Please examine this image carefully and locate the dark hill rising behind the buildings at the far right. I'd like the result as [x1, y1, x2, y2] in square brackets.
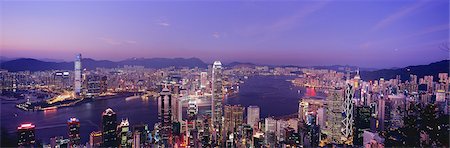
[360, 60, 450, 81]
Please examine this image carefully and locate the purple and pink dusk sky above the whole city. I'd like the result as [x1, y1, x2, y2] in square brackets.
[0, 0, 449, 68]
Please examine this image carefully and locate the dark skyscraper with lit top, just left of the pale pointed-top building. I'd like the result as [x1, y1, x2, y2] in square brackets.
[102, 108, 118, 147]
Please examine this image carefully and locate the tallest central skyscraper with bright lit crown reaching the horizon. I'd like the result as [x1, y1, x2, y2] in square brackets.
[211, 61, 223, 145]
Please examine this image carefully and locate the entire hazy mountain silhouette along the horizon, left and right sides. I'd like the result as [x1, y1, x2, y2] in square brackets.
[0, 58, 450, 81]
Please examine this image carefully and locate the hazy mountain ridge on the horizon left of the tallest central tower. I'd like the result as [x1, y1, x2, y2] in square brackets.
[0, 58, 207, 72]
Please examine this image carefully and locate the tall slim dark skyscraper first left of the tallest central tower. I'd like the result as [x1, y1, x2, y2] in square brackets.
[159, 86, 172, 146]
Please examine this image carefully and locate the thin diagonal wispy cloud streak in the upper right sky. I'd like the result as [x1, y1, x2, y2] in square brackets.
[372, 0, 427, 30]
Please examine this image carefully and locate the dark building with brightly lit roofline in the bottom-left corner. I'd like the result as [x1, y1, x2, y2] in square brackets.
[17, 123, 36, 147]
